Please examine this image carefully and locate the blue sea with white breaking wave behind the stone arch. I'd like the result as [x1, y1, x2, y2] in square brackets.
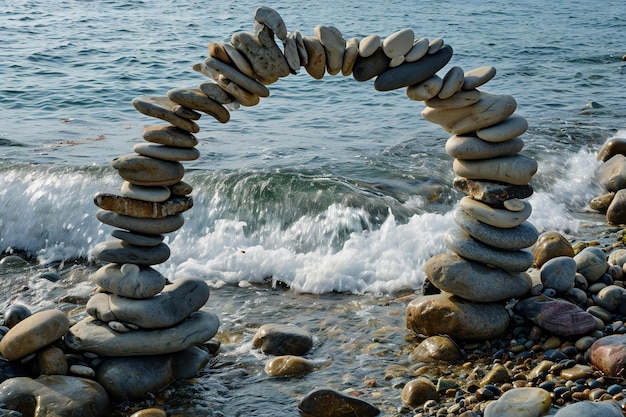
[0, 0, 626, 416]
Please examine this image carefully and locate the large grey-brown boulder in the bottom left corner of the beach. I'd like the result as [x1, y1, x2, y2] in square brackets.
[0, 375, 110, 417]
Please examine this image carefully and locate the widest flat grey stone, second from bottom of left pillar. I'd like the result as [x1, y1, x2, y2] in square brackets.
[64, 311, 220, 356]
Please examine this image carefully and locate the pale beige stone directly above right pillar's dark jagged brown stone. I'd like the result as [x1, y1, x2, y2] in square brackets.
[452, 154, 537, 185]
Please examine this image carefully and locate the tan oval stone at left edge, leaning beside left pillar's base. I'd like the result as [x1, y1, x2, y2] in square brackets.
[0, 309, 70, 361]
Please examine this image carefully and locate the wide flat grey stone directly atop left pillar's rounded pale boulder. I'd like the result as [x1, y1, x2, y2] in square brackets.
[91, 240, 170, 266]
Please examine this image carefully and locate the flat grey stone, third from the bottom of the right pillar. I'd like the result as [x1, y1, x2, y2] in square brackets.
[443, 227, 533, 272]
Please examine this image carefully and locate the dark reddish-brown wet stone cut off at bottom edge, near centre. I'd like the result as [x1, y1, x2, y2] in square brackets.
[298, 389, 380, 417]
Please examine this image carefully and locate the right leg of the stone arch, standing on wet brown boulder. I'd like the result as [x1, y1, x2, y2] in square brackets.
[407, 67, 539, 339]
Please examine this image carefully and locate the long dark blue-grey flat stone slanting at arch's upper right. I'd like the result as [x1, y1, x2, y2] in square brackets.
[374, 45, 452, 91]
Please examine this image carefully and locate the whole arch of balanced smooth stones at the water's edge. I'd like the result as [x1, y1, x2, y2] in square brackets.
[75, 6, 538, 360]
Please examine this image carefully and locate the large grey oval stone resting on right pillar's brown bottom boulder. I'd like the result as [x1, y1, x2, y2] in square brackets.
[424, 254, 532, 303]
